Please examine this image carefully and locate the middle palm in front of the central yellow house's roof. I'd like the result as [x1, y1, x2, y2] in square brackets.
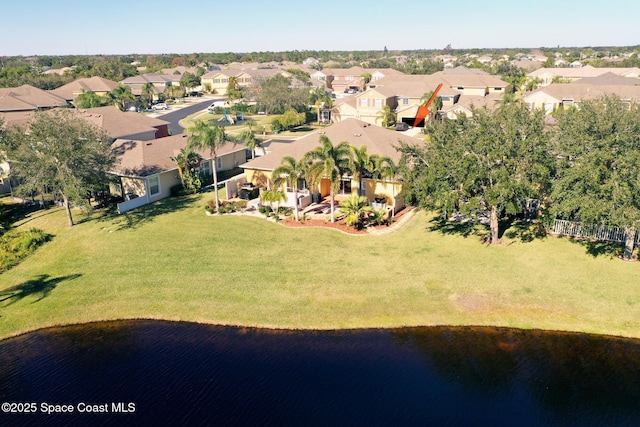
[305, 135, 351, 222]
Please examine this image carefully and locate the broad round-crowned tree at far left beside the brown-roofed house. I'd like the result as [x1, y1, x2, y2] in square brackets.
[4, 110, 116, 226]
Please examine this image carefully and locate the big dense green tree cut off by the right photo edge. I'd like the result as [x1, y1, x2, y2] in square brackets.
[551, 96, 640, 259]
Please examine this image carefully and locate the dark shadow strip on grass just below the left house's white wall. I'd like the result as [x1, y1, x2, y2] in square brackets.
[94, 196, 197, 231]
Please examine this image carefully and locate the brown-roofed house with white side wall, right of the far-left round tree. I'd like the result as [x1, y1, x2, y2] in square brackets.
[111, 133, 247, 213]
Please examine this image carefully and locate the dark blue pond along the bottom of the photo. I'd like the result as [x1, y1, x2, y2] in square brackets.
[0, 321, 640, 426]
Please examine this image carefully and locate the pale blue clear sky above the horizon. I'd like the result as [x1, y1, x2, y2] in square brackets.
[0, 0, 640, 56]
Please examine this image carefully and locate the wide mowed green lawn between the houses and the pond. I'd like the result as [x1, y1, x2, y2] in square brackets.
[0, 194, 640, 338]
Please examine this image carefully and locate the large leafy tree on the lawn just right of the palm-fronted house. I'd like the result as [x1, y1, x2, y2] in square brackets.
[401, 102, 552, 244]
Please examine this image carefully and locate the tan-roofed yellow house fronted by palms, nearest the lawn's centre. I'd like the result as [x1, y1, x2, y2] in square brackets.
[240, 119, 420, 211]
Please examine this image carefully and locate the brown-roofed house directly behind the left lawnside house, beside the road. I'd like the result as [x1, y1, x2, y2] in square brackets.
[76, 106, 169, 141]
